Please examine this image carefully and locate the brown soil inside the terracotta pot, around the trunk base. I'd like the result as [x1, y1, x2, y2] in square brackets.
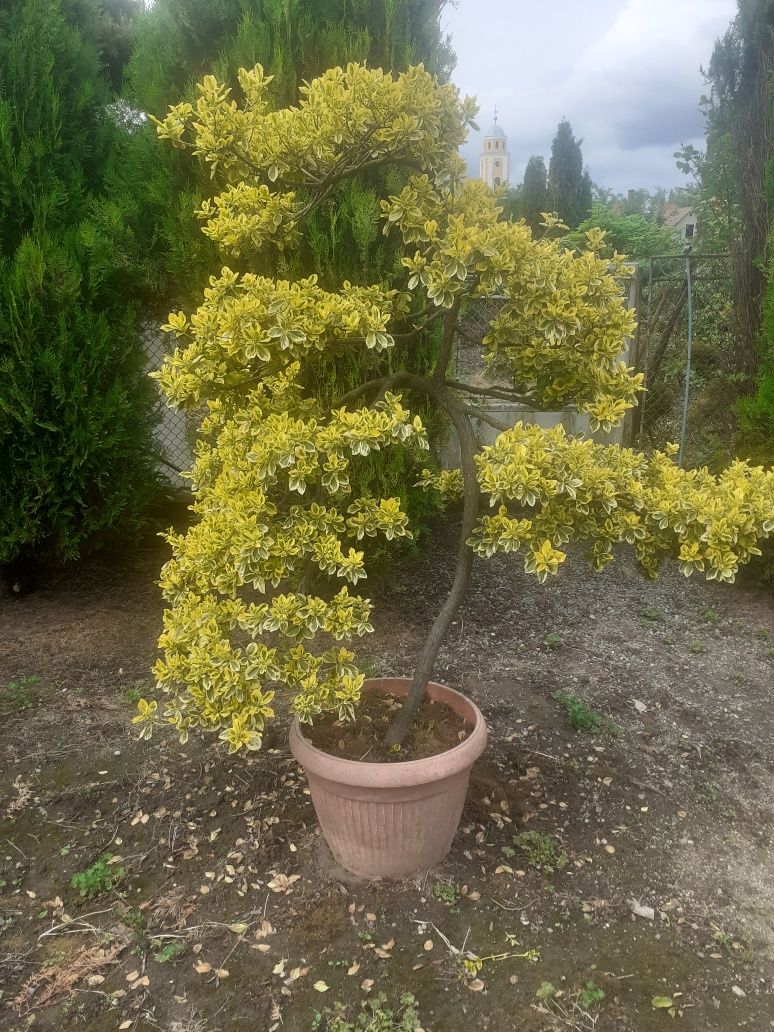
[302, 691, 471, 764]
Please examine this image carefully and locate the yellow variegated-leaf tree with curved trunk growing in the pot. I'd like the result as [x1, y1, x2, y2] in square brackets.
[135, 64, 774, 750]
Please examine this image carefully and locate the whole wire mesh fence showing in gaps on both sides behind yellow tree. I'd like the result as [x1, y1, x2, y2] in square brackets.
[142, 253, 733, 487]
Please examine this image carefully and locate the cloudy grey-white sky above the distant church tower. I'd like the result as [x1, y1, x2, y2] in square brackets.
[444, 0, 736, 191]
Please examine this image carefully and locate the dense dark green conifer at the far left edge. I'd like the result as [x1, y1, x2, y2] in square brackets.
[0, 0, 154, 582]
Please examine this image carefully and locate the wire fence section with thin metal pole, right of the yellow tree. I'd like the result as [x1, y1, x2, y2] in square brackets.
[634, 252, 734, 466]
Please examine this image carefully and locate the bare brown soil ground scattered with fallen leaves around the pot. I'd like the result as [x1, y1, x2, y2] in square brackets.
[0, 525, 774, 1032]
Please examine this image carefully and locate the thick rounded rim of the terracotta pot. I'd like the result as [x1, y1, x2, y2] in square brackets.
[290, 677, 488, 788]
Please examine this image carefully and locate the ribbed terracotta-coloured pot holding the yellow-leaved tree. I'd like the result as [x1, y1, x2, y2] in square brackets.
[290, 677, 487, 878]
